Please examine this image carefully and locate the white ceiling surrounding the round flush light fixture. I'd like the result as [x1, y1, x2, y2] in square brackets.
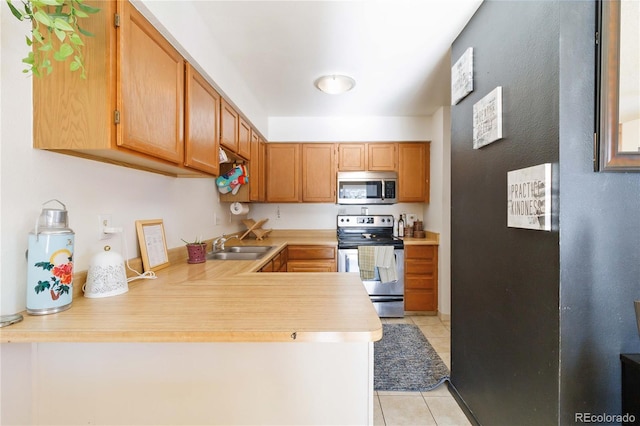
[193, 0, 482, 117]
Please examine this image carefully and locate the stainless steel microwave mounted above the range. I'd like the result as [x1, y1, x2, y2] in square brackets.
[336, 172, 398, 204]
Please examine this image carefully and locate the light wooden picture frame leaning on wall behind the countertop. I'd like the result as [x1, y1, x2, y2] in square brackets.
[136, 219, 169, 272]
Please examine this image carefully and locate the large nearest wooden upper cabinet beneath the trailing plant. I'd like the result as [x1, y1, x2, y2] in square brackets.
[32, 1, 212, 176]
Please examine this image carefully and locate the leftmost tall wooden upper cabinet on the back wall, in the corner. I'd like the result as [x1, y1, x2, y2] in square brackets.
[264, 143, 301, 203]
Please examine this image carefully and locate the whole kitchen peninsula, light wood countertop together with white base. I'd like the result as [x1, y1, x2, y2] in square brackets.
[0, 238, 382, 424]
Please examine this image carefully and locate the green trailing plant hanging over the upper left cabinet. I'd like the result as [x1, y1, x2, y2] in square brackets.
[6, 0, 100, 79]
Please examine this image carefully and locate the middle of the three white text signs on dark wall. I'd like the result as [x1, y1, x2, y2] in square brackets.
[473, 86, 502, 149]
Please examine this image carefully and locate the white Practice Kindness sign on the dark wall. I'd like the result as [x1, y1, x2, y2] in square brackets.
[507, 163, 551, 231]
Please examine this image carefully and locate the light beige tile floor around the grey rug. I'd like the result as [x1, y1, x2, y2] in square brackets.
[373, 316, 471, 426]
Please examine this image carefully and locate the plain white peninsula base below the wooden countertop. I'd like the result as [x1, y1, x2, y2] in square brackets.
[0, 342, 373, 425]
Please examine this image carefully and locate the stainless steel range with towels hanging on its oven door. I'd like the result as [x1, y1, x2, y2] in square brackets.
[337, 215, 404, 317]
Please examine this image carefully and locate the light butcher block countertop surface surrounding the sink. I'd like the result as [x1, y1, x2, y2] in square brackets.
[0, 231, 382, 343]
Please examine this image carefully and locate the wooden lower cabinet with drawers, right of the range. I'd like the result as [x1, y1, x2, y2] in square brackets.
[404, 245, 438, 311]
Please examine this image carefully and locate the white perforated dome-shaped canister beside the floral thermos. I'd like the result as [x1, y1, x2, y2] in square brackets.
[82, 246, 129, 298]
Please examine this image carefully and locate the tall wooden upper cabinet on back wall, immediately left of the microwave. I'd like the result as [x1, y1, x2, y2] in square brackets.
[301, 143, 336, 203]
